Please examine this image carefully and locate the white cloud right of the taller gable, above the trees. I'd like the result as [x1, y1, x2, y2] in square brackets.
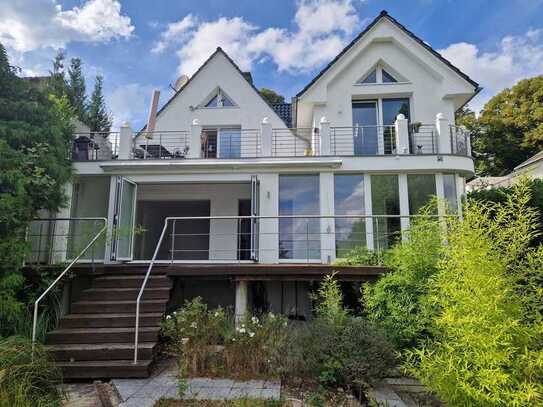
[439, 29, 543, 112]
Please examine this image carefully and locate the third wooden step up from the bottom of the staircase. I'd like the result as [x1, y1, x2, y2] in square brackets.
[46, 326, 160, 345]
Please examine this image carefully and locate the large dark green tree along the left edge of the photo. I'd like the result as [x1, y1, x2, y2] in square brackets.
[0, 44, 72, 336]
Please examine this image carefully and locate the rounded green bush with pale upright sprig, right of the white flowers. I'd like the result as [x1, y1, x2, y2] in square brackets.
[285, 276, 394, 387]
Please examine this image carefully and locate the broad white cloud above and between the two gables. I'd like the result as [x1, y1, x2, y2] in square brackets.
[153, 0, 360, 74]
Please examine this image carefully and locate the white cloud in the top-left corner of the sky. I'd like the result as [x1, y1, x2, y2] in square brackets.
[0, 0, 134, 53]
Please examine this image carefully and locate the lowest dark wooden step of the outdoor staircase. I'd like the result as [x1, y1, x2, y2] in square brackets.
[57, 359, 152, 380]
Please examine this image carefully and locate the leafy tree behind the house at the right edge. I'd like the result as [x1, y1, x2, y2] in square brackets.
[458, 76, 543, 176]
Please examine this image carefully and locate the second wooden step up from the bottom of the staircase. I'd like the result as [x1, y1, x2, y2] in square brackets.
[45, 342, 156, 362]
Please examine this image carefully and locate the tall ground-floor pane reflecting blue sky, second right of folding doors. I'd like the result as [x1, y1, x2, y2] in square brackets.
[334, 174, 366, 257]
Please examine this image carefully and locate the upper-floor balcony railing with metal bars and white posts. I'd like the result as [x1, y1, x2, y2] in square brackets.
[71, 115, 471, 161]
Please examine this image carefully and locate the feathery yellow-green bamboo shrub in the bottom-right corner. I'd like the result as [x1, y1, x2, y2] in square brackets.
[406, 184, 543, 406]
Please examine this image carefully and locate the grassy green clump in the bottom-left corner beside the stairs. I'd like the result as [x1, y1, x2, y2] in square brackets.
[0, 336, 63, 407]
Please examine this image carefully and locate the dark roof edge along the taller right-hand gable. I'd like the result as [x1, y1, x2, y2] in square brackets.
[296, 10, 482, 97]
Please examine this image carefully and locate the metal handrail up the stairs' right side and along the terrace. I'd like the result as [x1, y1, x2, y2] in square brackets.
[133, 214, 452, 364]
